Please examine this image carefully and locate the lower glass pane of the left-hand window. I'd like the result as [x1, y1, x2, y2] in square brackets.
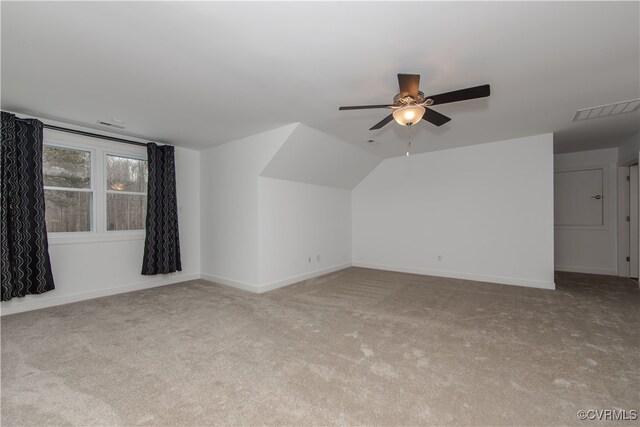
[44, 190, 93, 233]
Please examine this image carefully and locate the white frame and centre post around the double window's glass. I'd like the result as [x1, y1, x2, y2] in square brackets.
[44, 129, 148, 245]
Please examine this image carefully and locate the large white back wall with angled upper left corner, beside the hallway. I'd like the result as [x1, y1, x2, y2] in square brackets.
[352, 134, 554, 288]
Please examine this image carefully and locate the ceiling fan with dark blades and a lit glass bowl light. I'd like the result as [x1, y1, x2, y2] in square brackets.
[339, 74, 491, 130]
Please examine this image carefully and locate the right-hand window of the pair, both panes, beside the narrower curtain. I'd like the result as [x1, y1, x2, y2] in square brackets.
[106, 155, 148, 231]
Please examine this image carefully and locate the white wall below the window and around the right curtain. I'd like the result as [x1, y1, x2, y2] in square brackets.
[2, 147, 200, 315]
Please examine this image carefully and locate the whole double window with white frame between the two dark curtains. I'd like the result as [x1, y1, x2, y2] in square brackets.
[43, 129, 148, 237]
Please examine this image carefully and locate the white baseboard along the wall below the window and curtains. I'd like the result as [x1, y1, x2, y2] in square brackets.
[0, 273, 200, 316]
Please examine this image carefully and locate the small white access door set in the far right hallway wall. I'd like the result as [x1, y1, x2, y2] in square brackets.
[553, 169, 604, 226]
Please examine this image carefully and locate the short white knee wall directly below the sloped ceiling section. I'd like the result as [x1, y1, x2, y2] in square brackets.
[259, 178, 351, 291]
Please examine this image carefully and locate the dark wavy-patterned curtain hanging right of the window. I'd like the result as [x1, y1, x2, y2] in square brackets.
[142, 143, 182, 275]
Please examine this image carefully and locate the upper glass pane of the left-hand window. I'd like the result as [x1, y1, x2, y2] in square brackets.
[42, 145, 91, 188]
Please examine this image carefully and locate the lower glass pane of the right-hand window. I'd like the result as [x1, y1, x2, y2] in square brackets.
[107, 193, 147, 231]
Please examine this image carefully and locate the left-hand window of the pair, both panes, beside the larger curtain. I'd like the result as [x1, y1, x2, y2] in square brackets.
[42, 145, 93, 232]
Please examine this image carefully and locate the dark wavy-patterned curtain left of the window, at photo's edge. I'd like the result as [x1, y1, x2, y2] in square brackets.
[0, 111, 54, 301]
